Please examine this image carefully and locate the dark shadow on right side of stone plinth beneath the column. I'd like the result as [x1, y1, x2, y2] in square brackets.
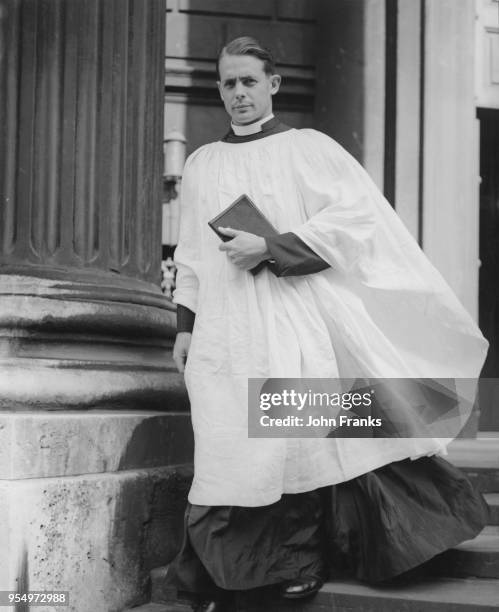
[108, 414, 194, 605]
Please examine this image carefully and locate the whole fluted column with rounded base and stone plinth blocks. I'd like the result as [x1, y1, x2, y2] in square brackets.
[0, 0, 192, 612]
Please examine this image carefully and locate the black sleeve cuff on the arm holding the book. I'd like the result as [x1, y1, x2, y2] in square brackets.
[265, 232, 331, 276]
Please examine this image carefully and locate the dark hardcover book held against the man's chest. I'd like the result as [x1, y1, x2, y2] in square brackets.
[208, 194, 279, 274]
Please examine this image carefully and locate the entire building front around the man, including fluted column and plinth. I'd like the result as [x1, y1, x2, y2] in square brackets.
[0, 0, 499, 612]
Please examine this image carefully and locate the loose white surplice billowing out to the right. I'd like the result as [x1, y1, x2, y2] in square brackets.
[174, 129, 487, 506]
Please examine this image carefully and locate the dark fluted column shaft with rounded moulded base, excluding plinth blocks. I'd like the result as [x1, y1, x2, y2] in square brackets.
[0, 0, 180, 408]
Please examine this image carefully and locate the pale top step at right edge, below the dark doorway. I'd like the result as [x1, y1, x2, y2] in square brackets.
[445, 434, 499, 493]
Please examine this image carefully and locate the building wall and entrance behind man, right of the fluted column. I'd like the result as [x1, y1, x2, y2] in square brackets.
[165, 0, 499, 430]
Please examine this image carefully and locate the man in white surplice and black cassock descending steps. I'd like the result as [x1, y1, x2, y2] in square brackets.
[170, 37, 487, 611]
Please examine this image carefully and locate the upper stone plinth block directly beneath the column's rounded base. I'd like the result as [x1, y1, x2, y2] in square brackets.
[0, 410, 194, 479]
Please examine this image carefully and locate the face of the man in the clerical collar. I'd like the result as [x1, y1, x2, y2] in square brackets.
[218, 55, 281, 125]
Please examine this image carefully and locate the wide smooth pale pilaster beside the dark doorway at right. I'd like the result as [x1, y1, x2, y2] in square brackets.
[422, 0, 479, 318]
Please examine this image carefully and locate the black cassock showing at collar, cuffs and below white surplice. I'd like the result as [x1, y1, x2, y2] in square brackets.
[168, 119, 488, 594]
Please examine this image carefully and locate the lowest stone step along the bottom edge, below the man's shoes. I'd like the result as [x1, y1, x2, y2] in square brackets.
[146, 578, 499, 612]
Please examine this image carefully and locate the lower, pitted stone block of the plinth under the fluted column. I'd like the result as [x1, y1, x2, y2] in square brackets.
[0, 466, 192, 612]
